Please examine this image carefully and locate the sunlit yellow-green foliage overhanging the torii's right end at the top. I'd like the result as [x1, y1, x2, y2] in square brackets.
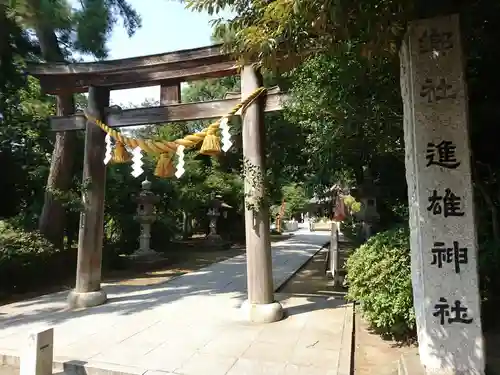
[185, 0, 415, 70]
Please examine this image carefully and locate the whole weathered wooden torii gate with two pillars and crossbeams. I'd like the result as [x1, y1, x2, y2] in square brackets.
[28, 45, 284, 322]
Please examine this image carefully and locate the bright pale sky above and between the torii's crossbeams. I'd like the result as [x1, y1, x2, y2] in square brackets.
[72, 0, 229, 106]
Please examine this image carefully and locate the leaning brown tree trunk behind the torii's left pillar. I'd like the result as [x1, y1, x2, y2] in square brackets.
[35, 22, 77, 248]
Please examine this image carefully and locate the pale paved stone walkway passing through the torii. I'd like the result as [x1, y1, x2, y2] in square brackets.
[0, 230, 352, 375]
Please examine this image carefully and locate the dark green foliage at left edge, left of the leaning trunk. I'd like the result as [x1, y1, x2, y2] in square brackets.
[0, 11, 54, 218]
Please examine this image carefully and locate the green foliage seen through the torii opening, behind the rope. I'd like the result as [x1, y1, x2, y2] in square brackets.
[101, 77, 250, 247]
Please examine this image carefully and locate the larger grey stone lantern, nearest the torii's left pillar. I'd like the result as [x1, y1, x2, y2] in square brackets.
[132, 179, 160, 257]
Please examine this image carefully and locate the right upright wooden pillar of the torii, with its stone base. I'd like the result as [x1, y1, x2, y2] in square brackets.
[241, 66, 283, 323]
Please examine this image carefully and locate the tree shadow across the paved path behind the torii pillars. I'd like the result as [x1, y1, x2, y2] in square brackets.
[0, 235, 332, 337]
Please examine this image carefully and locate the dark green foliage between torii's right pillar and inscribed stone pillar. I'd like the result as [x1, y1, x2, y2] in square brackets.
[285, 45, 404, 195]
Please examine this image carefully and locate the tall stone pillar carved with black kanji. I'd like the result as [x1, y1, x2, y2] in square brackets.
[400, 15, 485, 375]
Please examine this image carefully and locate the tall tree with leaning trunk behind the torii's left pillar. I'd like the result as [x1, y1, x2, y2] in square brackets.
[2, 0, 141, 247]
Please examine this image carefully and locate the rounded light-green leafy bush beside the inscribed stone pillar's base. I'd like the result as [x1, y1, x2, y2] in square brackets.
[347, 228, 415, 338]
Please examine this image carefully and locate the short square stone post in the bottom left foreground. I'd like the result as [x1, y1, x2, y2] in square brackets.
[20, 328, 54, 375]
